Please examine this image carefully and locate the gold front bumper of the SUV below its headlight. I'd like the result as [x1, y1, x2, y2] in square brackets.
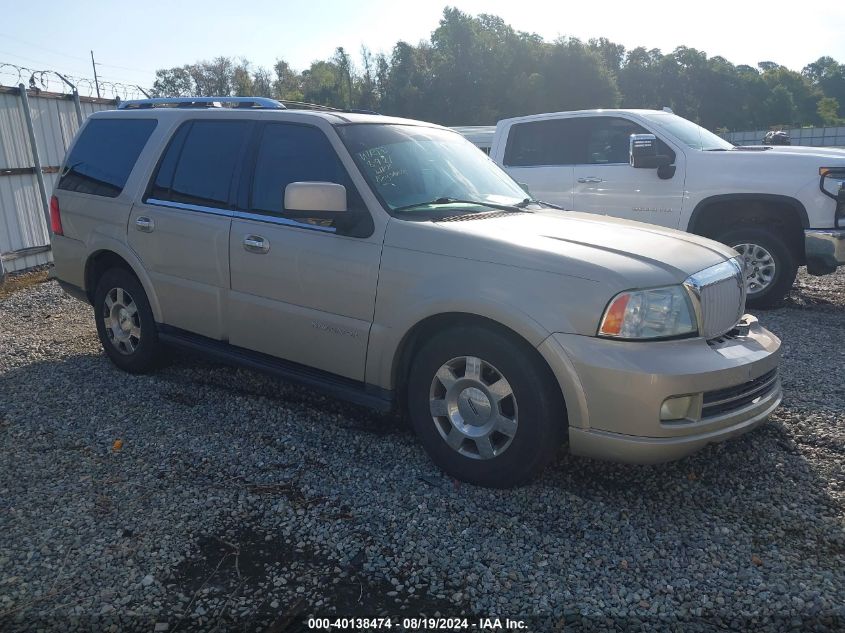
[540, 316, 782, 463]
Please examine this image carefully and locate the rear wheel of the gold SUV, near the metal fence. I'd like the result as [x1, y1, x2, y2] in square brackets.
[94, 268, 161, 374]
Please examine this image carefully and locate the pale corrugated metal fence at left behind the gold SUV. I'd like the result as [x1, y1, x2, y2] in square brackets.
[0, 86, 115, 272]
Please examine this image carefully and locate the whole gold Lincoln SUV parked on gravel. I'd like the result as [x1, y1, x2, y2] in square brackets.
[51, 98, 781, 486]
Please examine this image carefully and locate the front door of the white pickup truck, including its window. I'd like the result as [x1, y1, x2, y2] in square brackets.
[572, 116, 685, 228]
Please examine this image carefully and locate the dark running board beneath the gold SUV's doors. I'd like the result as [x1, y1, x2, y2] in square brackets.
[158, 325, 394, 412]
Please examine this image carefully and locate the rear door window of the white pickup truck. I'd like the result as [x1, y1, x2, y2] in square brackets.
[504, 118, 584, 167]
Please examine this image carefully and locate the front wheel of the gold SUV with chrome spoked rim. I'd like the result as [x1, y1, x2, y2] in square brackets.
[408, 327, 567, 488]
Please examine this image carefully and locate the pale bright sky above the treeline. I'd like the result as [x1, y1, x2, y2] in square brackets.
[0, 0, 845, 93]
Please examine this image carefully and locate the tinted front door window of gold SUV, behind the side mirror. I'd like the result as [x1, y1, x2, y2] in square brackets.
[250, 123, 364, 214]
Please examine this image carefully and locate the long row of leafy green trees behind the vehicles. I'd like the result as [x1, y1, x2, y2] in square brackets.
[148, 7, 845, 130]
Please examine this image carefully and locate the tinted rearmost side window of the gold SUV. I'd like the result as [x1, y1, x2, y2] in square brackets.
[59, 119, 156, 198]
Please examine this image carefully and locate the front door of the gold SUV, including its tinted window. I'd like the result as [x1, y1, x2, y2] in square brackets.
[229, 123, 382, 381]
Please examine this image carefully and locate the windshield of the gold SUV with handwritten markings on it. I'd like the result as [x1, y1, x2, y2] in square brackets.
[338, 124, 526, 213]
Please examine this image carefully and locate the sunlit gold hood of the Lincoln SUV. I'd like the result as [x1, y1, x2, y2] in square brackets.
[386, 210, 736, 292]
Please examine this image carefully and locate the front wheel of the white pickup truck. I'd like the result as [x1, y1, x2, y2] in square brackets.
[717, 227, 798, 308]
